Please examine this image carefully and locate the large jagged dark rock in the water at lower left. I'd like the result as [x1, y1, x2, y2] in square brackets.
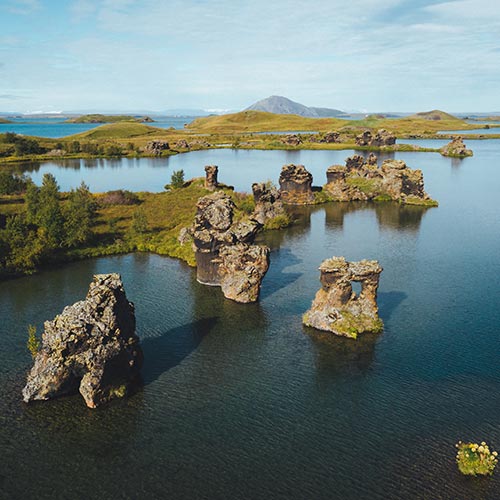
[23, 274, 143, 408]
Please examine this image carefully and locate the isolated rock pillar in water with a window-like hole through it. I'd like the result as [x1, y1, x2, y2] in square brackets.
[303, 257, 382, 338]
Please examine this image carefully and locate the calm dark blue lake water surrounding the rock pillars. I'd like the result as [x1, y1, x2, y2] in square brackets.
[0, 140, 500, 500]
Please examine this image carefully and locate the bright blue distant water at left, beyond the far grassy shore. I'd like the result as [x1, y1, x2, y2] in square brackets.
[0, 116, 194, 139]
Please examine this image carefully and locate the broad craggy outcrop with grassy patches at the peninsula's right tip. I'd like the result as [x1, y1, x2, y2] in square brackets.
[324, 154, 437, 206]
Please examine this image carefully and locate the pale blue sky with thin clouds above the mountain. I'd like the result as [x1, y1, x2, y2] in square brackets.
[0, 0, 500, 112]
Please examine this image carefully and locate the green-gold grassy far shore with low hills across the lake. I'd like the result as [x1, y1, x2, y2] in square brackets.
[0, 111, 492, 165]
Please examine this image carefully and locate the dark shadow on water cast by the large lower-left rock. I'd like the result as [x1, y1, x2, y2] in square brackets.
[141, 317, 218, 385]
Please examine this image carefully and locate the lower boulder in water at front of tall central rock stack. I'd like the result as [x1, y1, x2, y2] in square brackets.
[219, 243, 269, 303]
